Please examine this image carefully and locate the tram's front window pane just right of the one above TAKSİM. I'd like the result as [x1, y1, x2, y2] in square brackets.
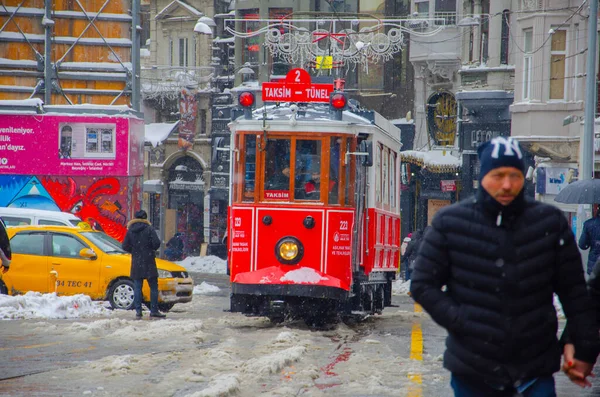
[294, 139, 324, 200]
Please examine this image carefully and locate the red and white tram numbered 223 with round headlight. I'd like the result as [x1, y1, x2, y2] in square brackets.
[228, 69, 401, 323]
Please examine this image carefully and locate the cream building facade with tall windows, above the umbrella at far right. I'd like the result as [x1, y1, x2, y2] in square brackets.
[510, 0, 598, 232]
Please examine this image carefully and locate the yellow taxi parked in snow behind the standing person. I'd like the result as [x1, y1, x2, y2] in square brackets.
[0, 224, 194, 311]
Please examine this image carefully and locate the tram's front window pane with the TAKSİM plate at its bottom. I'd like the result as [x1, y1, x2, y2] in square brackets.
[264, 139, 291, 200]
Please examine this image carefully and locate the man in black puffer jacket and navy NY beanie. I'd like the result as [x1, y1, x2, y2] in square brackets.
[411, 137, 599, 397]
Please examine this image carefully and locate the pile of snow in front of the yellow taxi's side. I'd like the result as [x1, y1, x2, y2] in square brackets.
[0, 291, 112, 319]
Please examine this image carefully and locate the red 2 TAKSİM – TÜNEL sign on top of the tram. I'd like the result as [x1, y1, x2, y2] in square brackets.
[262, 68, 333, 103]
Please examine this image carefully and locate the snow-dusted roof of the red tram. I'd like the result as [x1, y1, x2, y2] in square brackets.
[233, 103, 400, 142]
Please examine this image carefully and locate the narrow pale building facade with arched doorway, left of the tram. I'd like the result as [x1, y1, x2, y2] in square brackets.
[142, 0, 215, 256]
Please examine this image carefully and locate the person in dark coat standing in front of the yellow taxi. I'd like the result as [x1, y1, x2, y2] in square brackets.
[122, 210, 166, 319]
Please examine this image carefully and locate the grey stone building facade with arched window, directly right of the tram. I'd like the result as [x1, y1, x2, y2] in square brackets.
[402, 0, 515, 235]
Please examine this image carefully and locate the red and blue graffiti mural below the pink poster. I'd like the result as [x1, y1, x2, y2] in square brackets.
[0, 175, 132, 241]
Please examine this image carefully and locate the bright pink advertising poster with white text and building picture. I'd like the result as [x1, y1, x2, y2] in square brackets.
[0, 114, 135, 176]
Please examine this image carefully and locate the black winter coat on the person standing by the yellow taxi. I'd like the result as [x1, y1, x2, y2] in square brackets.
[122, 219, 160, 279]
